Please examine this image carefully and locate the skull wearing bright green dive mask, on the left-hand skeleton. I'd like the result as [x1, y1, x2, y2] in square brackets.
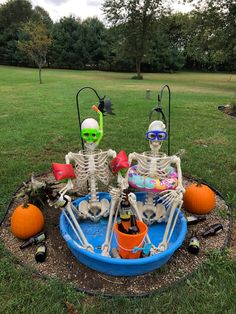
[81, 118, 101, 151]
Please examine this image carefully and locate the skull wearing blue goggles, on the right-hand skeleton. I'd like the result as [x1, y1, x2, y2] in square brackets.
[146, 120, 167, 152]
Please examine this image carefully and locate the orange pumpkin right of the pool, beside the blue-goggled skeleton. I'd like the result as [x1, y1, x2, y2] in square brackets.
[183, 183, 215, 215]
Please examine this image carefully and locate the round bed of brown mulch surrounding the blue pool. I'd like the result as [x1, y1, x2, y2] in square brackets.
[0, 173, 232, 296]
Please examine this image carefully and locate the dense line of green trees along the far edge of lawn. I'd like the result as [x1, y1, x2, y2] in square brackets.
[0, 0, 236, 73]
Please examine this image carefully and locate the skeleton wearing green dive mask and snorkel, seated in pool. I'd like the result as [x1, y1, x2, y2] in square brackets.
[53, 106, 116, 251]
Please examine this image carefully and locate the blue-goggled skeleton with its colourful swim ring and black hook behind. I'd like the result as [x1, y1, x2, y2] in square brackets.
[128, 86, 185, 251]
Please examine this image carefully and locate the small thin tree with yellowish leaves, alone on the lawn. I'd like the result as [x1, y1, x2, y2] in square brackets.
[18, 22, 52, 84]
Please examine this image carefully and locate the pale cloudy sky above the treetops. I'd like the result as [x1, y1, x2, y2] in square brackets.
[0, 0, 195, 22]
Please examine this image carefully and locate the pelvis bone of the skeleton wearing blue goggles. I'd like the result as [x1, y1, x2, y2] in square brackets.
[137, 202, 167, 225]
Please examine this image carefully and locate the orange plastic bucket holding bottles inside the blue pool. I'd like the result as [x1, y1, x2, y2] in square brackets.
[114, 220, 148, 259]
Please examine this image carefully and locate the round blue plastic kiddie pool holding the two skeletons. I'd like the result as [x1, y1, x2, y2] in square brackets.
[60, 192, 187, 276]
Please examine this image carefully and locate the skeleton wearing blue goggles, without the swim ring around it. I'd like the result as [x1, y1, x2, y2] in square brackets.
[129, 120, 184, 251]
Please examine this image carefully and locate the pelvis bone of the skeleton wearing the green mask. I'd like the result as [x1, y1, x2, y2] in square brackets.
[78, 198, 110, 221]
